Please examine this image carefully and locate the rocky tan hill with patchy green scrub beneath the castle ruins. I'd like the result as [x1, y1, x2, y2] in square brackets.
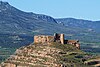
[1, 43, 98, 67]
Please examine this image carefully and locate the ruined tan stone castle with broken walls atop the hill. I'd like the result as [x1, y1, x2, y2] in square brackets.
[34, 33, 80, 48]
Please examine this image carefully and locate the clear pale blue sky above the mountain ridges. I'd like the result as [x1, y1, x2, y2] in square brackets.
[2, 0, 100, 20]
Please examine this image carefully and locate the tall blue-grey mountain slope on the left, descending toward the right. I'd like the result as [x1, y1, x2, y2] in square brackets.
[0, 1, 57, 34]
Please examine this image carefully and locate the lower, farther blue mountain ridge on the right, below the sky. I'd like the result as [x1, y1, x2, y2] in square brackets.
[56, 18, 100, 32]
